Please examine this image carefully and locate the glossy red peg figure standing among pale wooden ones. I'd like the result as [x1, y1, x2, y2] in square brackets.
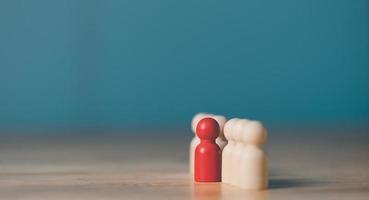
[195, 118, 222, 182]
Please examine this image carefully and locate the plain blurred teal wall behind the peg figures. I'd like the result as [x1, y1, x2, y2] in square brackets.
[0, 0, 369, 127]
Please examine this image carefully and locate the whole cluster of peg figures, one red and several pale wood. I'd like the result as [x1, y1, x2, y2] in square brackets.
[189, 113, 268, 190]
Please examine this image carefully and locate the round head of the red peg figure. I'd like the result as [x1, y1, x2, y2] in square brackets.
[196, 117, 220, 140]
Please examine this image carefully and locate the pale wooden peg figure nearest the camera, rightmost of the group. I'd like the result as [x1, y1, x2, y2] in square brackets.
[235, 121, 268, 190]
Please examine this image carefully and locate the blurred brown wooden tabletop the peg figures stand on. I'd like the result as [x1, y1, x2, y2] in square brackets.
[0, 127, 369, 200]
